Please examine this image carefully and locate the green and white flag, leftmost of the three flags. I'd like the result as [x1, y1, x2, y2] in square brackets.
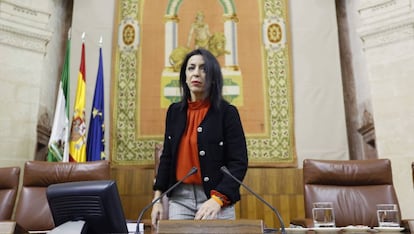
[47, 38, 70, 162]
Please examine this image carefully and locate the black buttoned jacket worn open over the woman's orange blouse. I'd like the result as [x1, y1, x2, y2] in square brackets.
[153, 100, 248, 204]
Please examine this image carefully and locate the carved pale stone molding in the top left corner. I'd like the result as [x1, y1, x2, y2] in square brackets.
[0, 0, 52, 54]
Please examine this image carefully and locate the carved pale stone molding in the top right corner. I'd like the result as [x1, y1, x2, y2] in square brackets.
[358, 0, 414, 49]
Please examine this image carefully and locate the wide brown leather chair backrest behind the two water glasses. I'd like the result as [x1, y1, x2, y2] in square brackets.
[303, 159, 401, 227]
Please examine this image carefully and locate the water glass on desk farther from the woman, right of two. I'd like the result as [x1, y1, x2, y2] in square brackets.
[377, 204, 400, 227]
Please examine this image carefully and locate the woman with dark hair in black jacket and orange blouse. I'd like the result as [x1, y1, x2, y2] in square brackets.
[151, 49, 248, 225]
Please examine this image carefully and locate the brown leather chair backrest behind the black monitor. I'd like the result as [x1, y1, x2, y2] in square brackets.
[15, 160, 110, 231]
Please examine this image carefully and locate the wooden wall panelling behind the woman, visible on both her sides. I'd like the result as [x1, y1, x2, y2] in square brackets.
[112, 166, 305, 227]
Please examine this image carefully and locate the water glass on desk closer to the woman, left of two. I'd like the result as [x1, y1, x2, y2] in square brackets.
[312, 202, 335, 227]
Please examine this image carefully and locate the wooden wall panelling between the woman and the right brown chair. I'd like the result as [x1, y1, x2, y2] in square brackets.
[238, 168, 305, 227]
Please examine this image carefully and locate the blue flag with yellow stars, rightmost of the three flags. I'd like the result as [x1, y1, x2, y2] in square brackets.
[86, 47, 105, 161]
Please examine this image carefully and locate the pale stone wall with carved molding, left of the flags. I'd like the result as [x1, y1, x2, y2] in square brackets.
[0, 0, 72, 166]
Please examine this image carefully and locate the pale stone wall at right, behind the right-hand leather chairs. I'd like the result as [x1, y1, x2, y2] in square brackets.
[357, 0, 414, 218]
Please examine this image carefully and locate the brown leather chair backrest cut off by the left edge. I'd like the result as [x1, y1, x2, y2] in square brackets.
[0, 167, 20, 220]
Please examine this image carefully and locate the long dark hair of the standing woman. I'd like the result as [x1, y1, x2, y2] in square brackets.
[180, 48, 223, 108]
